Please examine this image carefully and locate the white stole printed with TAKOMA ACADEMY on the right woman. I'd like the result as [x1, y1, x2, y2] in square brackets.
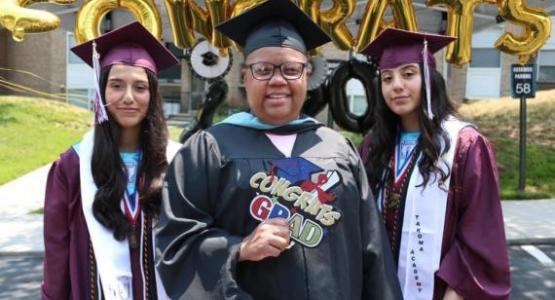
[378, 117, 471, 300]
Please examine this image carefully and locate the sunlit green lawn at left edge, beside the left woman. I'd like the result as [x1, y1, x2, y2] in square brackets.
[0, 96, 91, 184]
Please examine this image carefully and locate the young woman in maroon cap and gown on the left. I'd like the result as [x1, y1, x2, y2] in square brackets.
[42, 23, 177, 300]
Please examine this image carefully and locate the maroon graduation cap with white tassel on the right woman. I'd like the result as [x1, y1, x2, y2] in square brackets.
[362, 28, 457, 120]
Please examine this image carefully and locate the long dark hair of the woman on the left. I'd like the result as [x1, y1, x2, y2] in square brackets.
[91, 67, 168, 240]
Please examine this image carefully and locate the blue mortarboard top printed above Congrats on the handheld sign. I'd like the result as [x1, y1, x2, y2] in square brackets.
[272, 158, 322, 183]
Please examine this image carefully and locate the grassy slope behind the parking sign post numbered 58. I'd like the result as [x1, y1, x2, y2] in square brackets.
[459, 90, 555, 199]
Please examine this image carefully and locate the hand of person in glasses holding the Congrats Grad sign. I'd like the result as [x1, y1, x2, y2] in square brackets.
[239, 218, 289, 261]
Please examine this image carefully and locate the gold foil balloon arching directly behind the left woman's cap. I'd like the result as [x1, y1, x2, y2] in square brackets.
[75, 0, 162, 43]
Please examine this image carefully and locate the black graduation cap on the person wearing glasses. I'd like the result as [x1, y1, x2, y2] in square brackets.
[216, 0, 331, 55]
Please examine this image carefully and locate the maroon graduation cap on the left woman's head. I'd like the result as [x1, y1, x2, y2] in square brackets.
[71, 22, 179, 73]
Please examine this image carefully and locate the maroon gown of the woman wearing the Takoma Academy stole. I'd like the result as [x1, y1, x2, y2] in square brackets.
[361, 127, 511, 300]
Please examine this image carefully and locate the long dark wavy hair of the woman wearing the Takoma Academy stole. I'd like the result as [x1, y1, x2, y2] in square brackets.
[363, 64, 456, 192]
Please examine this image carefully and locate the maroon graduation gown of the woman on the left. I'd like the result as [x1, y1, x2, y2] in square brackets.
[41, 148, 157, 300]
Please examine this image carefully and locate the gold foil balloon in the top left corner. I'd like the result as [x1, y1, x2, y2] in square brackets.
[0, 0, 75, 41]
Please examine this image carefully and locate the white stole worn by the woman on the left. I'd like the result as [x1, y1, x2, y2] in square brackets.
[76, 130, 181, 300]
